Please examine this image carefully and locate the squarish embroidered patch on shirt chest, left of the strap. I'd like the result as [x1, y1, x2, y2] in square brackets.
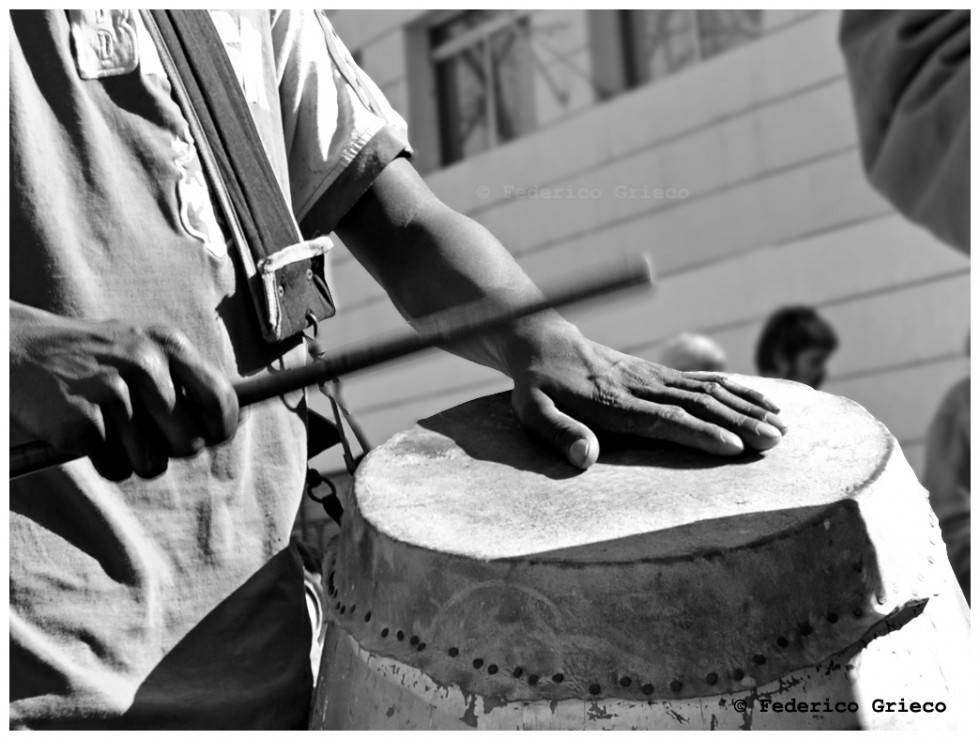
[68, 10, 140, 80]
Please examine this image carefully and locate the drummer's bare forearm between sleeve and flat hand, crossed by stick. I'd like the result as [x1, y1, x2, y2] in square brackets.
[338, 158, 577, 375]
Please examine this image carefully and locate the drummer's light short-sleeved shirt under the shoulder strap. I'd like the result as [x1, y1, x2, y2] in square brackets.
[9, 11, 408, 729]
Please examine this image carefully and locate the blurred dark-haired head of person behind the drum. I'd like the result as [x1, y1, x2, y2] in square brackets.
[755, 306, 837, 388]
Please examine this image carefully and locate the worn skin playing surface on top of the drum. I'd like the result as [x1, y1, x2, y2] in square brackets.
[357, 379, 894, 562]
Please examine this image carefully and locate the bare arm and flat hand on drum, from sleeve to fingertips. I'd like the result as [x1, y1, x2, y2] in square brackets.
[334, 158, 782, 468]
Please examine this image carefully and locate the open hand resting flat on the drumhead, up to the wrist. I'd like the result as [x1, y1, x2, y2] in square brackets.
[509, 324, 786, 469]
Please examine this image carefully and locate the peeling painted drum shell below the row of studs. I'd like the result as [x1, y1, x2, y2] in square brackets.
[310, 564, 976, 731]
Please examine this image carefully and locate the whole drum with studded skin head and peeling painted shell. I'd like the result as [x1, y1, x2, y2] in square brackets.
[311, 376, 972, 730]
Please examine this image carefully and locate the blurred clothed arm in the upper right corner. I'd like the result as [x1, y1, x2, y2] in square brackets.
[840, 9, 970, 254]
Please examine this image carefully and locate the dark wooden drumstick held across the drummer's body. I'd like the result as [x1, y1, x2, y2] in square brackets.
[10, 256, 653, 480]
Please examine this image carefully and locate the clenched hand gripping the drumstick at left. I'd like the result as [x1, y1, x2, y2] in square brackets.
[10, 302, 238, 480]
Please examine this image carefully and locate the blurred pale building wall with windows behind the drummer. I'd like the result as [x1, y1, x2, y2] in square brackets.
[299, 10, 969, 548]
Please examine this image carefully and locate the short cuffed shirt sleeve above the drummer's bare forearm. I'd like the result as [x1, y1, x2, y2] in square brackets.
[272, 11, 411, 237]
